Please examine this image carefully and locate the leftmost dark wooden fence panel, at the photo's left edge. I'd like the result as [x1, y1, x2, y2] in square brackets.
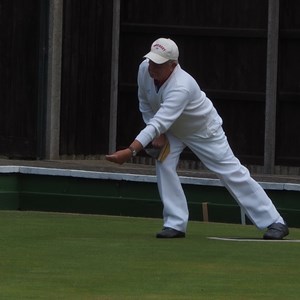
[0, 0, 40, 158]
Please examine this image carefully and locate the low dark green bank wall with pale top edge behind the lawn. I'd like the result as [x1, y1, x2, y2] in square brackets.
[0, 166, 300, 227]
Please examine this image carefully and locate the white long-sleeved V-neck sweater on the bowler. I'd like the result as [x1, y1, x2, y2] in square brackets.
[136, 59, 222, 147]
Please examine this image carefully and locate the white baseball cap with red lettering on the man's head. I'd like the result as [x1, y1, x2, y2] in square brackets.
[144, 38, 179, 64]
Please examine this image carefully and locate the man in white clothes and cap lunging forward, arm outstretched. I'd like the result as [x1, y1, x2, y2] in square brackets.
[106, 38, 289, 239]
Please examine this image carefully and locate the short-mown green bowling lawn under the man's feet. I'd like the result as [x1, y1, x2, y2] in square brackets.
[0, 211, 300, 300]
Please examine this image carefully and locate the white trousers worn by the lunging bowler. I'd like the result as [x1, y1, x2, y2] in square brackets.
[156, 127, 284, 232]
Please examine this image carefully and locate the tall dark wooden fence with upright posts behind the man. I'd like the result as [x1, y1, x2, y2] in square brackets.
[0, 0, 300, 172]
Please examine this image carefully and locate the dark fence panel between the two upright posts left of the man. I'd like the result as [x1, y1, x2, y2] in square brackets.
[60, 0, 112, 157]
